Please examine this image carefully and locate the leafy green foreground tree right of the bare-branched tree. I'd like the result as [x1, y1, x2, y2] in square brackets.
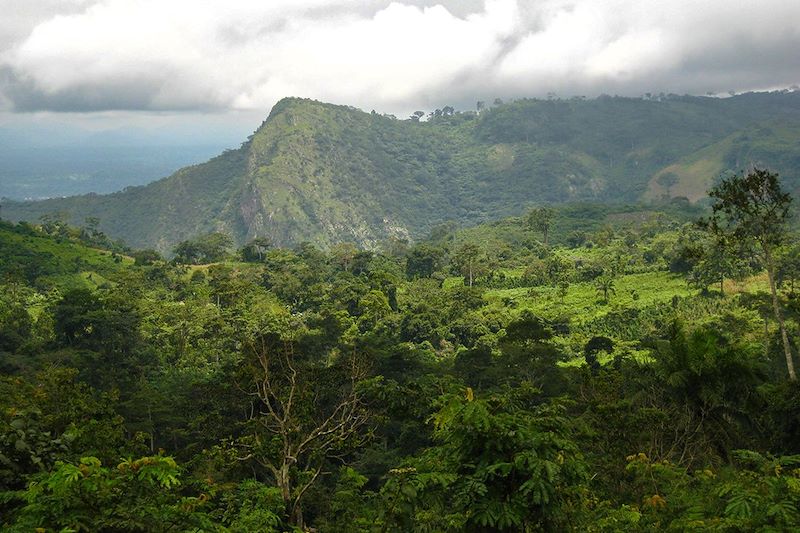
[381, 384, 586, 531]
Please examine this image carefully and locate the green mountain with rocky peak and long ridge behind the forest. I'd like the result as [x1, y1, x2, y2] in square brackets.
[2, 91, 800, 251]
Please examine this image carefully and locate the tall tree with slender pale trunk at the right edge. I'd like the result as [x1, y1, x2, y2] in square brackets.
[701, 168, 797, 381]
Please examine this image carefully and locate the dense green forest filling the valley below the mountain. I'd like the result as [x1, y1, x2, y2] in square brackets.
[0, 186, 800, 532]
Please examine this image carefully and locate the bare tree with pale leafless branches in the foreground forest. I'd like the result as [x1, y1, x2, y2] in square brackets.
[241, 333, 369, 528]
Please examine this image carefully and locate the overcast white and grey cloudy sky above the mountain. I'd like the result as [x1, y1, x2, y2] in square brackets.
[0, 0, 800, 139]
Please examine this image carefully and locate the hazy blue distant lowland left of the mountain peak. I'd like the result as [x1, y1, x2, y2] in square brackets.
[0, 113, 252, 200]
